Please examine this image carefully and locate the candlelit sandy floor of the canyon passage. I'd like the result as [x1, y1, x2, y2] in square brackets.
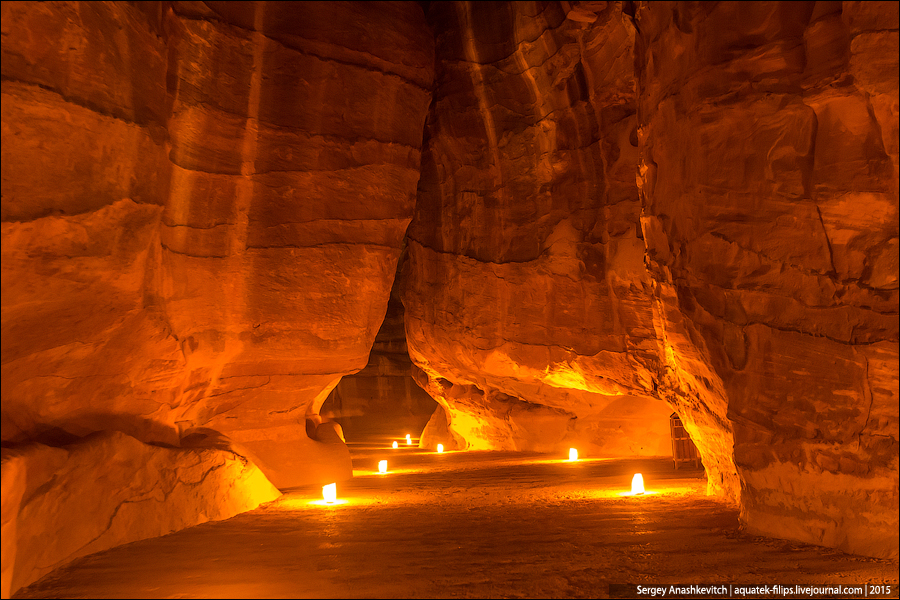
[16, 440, 897, 598]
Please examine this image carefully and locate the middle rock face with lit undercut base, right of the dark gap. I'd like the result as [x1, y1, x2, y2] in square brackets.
[403, 2, 671, 455]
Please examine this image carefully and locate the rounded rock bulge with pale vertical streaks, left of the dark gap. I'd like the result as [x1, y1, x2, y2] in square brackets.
[154, 2, 433, 487]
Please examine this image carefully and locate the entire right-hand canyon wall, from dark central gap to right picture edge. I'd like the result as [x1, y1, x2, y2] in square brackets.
[403, 2, 898, 557]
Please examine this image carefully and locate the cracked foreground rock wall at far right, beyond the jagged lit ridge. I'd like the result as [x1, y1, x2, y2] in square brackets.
[635, 2, 898, 558]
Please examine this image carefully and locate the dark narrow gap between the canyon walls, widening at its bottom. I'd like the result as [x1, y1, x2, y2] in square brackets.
[320, 252, 436, 441]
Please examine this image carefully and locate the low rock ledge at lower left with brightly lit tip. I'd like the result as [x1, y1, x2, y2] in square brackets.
[2, 432, 281, 598]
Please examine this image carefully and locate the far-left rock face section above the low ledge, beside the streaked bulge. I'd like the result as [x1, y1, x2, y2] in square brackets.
[0, 2, 183, 444]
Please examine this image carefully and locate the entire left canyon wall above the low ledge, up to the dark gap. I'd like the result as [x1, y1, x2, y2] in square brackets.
[2, 2, 433, 487]
